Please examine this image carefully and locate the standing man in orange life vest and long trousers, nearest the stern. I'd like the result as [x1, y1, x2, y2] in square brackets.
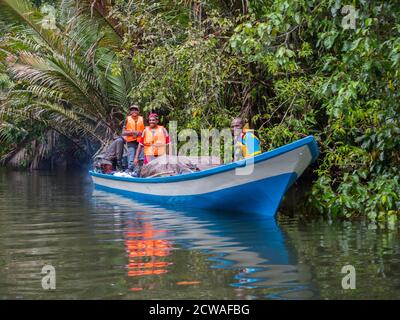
[122, 104, 144, 171]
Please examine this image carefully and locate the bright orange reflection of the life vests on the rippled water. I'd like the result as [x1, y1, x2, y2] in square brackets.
[125, 219, 172, 277]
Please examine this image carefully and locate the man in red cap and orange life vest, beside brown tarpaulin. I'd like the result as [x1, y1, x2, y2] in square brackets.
[134, 113, 170, 164]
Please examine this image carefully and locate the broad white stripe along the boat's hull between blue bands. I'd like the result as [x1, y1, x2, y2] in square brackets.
[92, 146, 312, 196]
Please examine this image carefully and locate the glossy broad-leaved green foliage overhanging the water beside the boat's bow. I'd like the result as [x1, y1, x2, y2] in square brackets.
[225, 0, 400, 220]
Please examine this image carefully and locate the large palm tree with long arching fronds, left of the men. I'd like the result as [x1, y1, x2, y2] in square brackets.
[0, 0, 134, 168]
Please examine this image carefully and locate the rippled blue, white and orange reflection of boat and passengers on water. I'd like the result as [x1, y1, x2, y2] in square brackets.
[93, 189, 315, 299]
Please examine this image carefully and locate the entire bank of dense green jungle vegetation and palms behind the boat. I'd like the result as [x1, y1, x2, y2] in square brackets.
[0, 0, 400, 222]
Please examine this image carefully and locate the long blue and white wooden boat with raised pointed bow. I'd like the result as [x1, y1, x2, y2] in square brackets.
[89, 136, 319, 216]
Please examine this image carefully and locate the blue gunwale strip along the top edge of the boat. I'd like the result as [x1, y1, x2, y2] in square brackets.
[89, 136, 319, 183]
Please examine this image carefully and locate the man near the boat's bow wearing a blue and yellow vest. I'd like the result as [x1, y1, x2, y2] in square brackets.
[231, 118, 261, 161]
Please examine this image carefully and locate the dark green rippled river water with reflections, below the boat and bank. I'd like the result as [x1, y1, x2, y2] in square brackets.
[0, 171, 400, 299]
